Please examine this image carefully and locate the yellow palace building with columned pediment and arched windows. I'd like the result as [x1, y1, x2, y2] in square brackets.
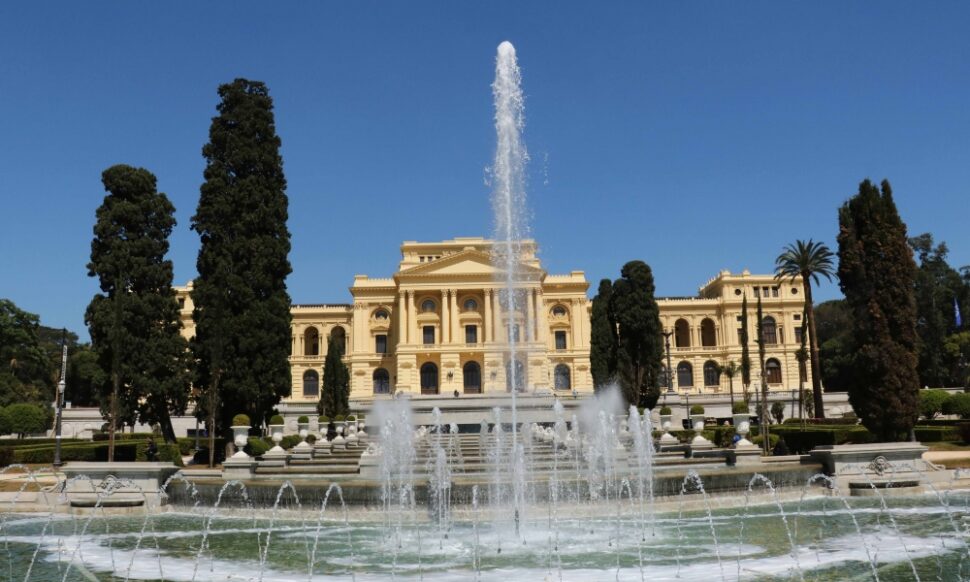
[176, 238, 804, 404]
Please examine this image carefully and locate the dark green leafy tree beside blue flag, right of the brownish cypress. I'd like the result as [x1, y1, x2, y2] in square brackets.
[909, 233, 970, 387]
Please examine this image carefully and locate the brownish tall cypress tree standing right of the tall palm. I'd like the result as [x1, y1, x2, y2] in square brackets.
[838, 180, 919, 441]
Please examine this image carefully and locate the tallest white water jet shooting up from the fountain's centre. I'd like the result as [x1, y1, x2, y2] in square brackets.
[492, 41, 532, 531]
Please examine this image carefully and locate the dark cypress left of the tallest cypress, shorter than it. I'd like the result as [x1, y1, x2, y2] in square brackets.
[85, 165, 188, 460]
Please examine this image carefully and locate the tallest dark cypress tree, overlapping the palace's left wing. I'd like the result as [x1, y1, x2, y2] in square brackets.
[192, 79, 291, 461]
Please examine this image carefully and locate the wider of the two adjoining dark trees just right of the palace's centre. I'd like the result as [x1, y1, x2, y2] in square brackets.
[610, 261, 663, 409]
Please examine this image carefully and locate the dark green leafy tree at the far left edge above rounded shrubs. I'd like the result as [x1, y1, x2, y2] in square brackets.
[0, 299, 54, 405]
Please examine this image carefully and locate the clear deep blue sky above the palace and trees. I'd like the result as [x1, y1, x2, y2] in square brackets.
[0, 1, 970, 336]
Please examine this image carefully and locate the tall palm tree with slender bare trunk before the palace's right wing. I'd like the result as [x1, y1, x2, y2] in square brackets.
[775, 239, 835, 418]
